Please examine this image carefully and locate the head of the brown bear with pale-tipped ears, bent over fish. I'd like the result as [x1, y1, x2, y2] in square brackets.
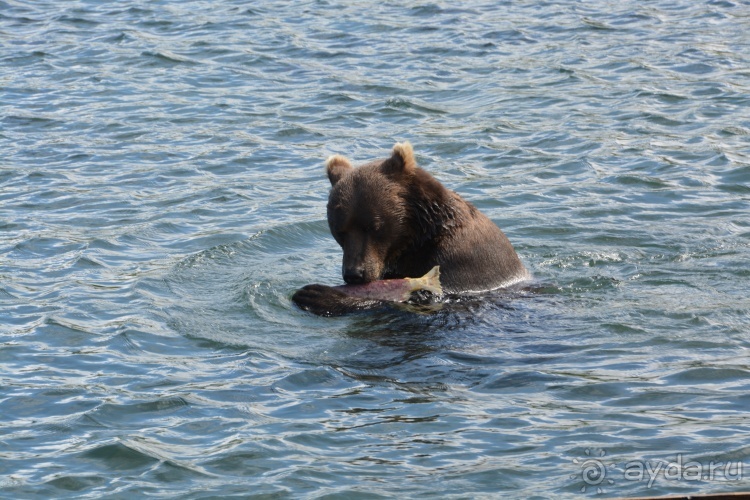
[326, 142, 451, 284]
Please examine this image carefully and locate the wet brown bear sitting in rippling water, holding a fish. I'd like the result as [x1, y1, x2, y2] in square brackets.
[292, 142, 529, 316]
